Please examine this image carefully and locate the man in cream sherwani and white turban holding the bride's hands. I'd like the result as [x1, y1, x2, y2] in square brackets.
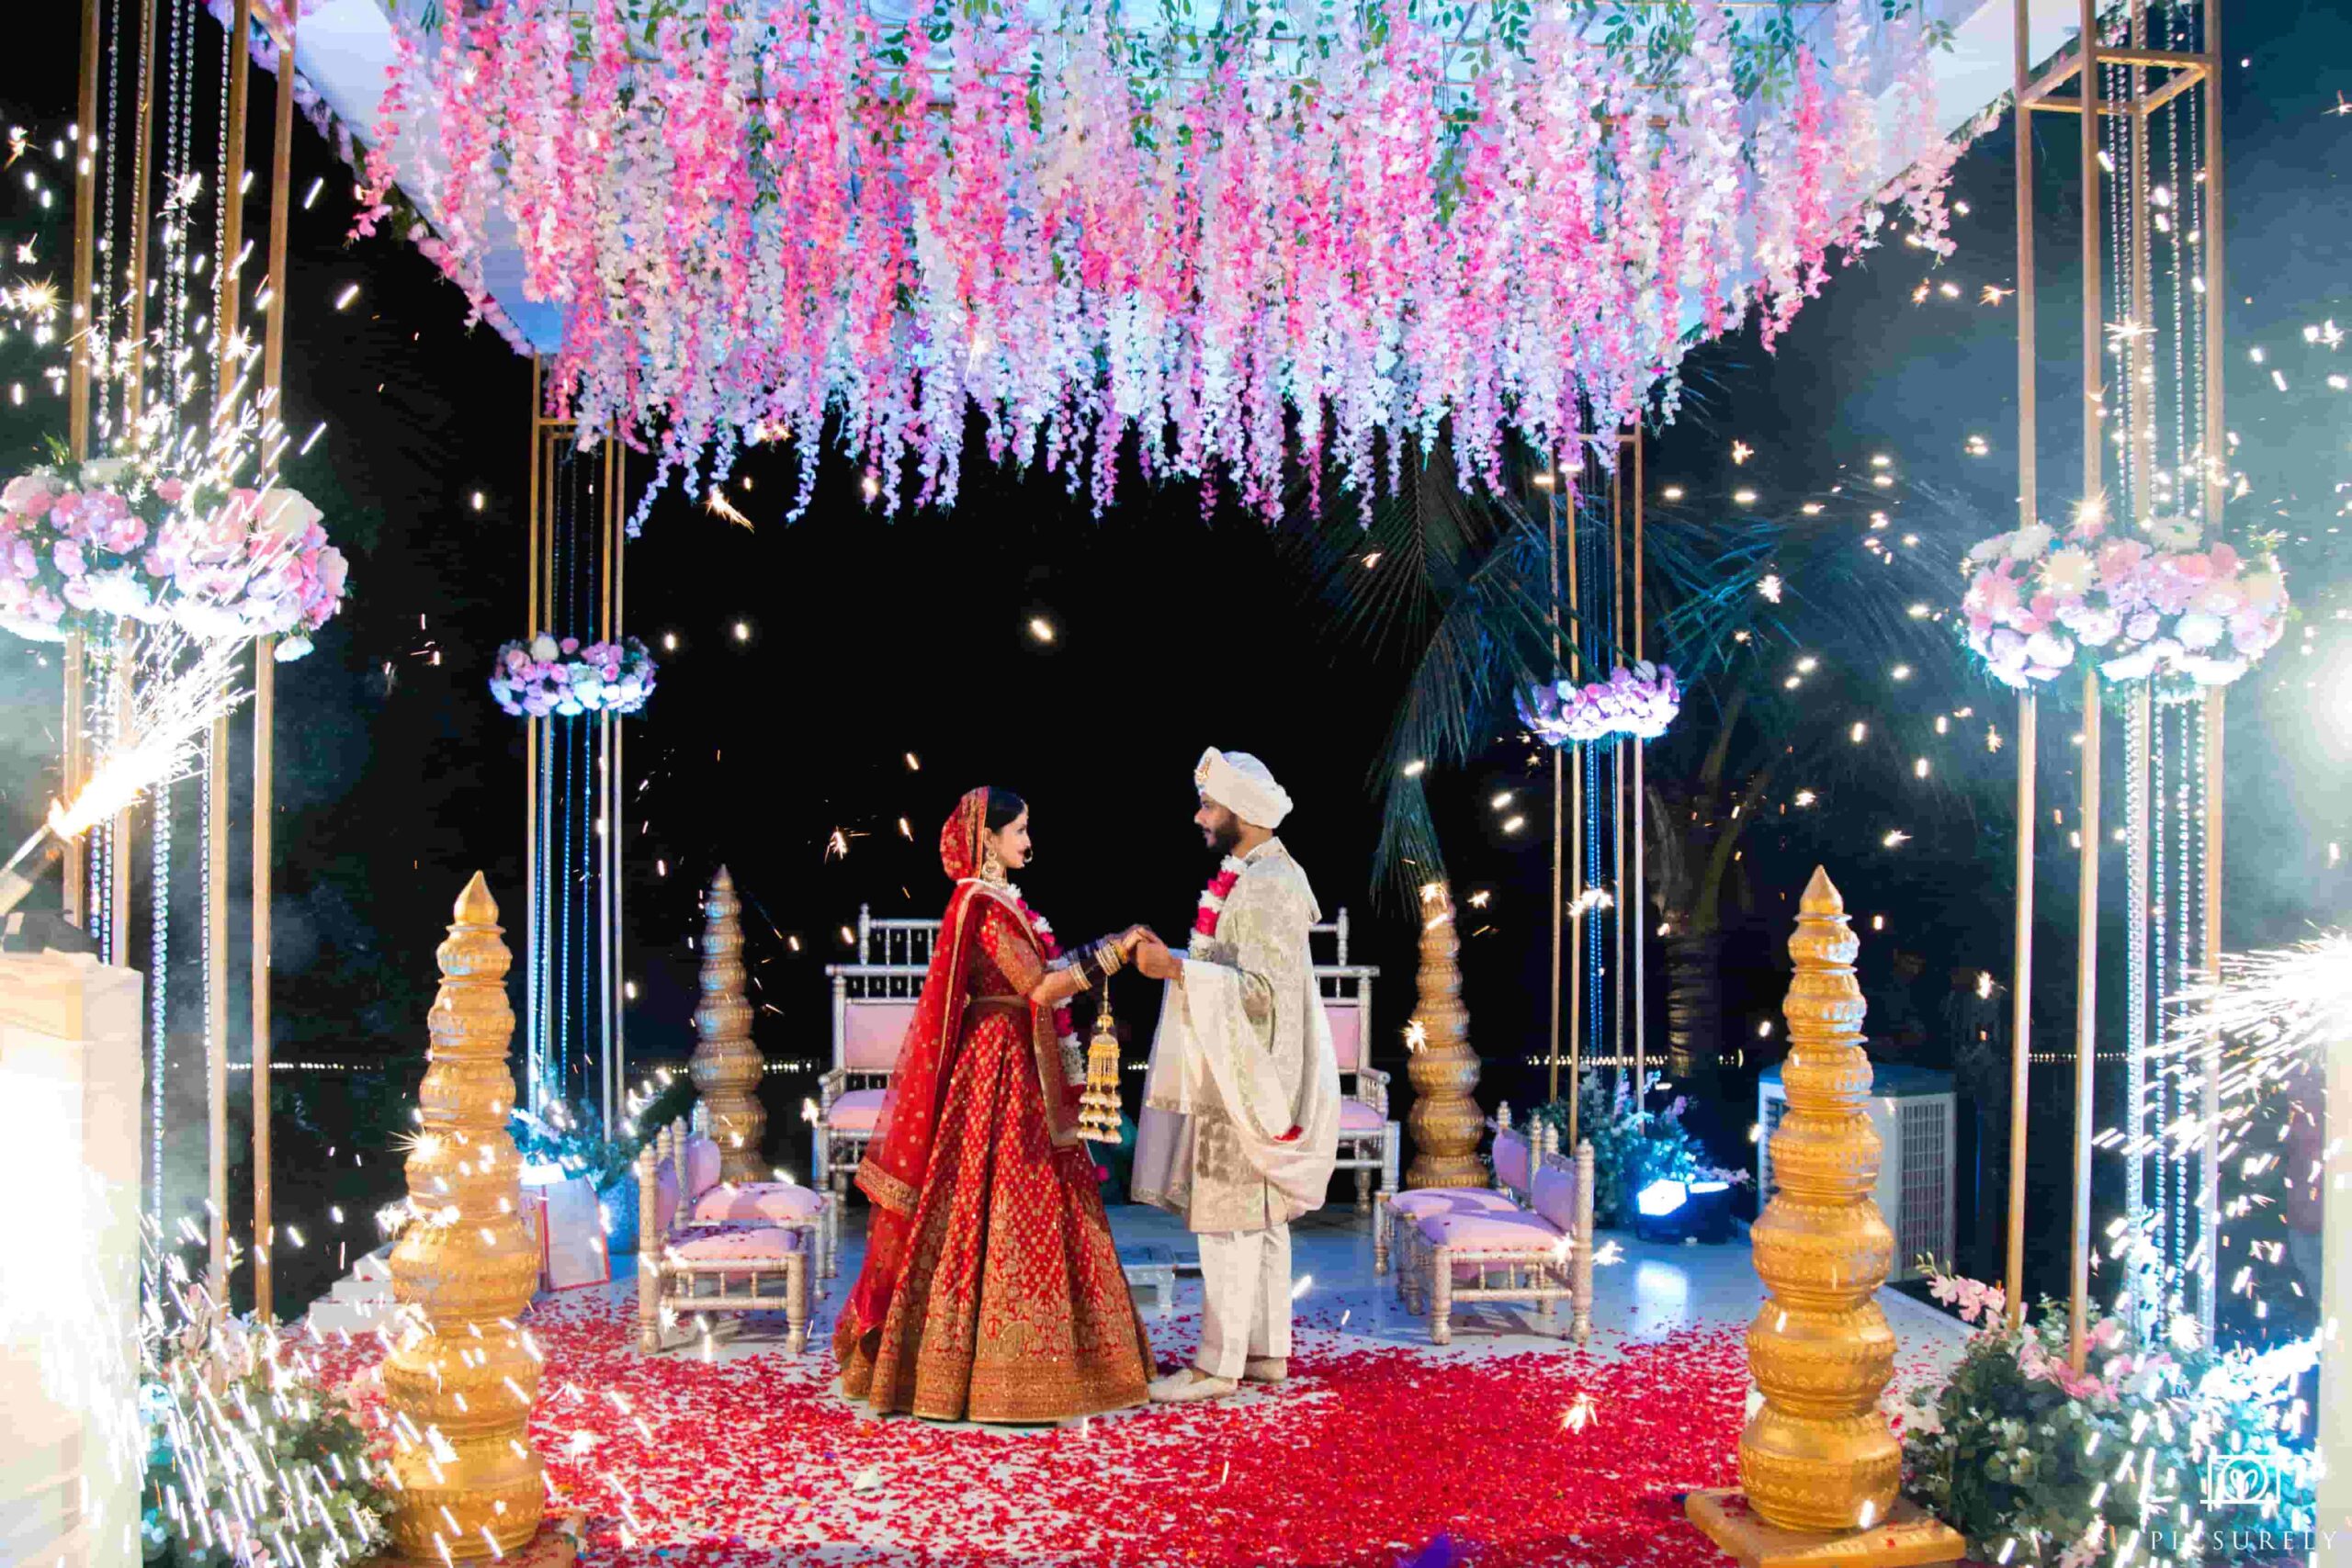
[1134, 748, 1339, 1404]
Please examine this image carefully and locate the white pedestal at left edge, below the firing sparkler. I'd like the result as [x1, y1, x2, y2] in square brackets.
[0, 952, 146, 1568]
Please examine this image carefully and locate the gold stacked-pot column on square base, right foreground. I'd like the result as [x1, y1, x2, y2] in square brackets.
[1687, 867, 1966, 1563]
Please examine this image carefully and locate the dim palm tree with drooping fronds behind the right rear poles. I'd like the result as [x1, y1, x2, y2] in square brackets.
[1306, 451, 2007, 1079]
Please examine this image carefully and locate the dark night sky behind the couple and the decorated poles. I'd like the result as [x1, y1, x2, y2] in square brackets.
[0, 5, 2352, 1325]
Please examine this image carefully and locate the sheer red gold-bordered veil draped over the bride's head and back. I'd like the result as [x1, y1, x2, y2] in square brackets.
[847, 790, 1077, 1336]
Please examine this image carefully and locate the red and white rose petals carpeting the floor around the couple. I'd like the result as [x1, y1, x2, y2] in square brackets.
[329, 1293, 1956, 1568]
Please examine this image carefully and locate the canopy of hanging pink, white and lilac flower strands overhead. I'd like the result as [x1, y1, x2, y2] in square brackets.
[362, 0, 1957, 517]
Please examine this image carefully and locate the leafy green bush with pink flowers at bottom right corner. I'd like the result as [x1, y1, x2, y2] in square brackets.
[1903, 1277, 2312, 1568]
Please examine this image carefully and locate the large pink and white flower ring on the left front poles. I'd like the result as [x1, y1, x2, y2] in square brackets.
[0, 458, 345, 660]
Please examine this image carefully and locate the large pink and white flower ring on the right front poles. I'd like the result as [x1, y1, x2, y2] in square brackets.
[1959, 514, 2286, 694]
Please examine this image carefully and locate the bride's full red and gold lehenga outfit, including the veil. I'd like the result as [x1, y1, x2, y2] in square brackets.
[832, 790, 1152, 1422]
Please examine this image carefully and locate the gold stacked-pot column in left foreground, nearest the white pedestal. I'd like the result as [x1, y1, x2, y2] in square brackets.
[383, 872, 566, 1563]
